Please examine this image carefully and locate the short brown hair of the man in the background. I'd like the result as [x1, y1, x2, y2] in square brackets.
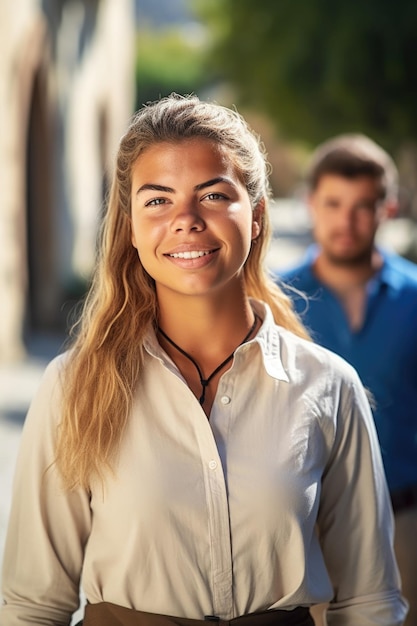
[307, 134, 398, 199]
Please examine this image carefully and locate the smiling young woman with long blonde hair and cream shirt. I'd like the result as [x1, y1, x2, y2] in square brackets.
[0, 95, 406, 626]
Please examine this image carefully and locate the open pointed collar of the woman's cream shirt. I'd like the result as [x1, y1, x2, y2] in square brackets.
[143, 299, 289, 382]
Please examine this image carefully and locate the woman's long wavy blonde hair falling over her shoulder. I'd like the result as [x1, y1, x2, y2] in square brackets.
[56, 94, 307, 489]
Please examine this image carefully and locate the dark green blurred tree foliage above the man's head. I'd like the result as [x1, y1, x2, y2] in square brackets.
[193, 0, 417, 149]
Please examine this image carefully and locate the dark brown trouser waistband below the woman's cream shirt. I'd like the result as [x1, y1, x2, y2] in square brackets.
[78, 602, 314, 626]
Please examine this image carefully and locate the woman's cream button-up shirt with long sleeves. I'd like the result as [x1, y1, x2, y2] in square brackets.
[0, 303, 405, 626]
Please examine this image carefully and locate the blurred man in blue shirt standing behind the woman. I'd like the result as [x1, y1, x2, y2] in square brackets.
[281, 135, 417, 626]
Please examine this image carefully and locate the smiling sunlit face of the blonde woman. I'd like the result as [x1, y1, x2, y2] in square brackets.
[131, 138, 260, 298]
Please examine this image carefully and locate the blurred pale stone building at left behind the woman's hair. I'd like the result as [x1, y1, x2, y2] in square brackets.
[0, 0, 135, 361]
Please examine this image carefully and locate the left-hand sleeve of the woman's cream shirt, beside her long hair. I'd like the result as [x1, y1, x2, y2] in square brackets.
[0, 357, 91, 626]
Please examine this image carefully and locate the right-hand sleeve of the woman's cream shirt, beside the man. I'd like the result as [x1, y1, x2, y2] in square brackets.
[318, 374, 407, 626]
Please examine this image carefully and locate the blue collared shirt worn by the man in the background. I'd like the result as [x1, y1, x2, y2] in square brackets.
[280, 245, 417, 491]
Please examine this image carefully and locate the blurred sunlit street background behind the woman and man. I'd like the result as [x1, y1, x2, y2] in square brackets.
[0, 0, 417, 616]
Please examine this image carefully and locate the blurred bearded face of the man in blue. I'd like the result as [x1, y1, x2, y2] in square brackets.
[309, 174, 384, 265]
